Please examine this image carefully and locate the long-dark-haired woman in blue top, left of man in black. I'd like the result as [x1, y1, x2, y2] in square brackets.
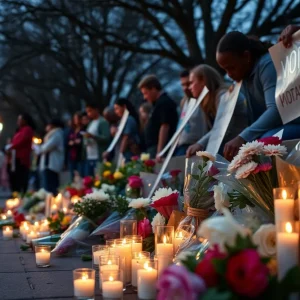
[103, 98, 140, 161]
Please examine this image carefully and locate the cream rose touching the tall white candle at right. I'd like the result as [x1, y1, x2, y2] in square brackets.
[252, 224, 276, 257]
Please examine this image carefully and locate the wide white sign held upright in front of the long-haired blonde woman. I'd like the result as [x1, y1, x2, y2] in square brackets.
[206, 82, 242, 155]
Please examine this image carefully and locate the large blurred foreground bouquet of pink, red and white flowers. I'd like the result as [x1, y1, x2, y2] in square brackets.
[157, 209, 300, 300]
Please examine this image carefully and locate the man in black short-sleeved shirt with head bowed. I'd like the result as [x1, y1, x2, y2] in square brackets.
[138, 75, 178, 161]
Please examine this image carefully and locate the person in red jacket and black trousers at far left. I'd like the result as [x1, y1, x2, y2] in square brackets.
[6, 113, 35, 194]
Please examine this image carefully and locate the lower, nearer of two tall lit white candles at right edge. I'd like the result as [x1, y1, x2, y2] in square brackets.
[277, 222, 299, 280]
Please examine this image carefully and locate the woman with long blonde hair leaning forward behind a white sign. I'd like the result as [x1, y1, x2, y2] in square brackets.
[186, 64, 247, 157]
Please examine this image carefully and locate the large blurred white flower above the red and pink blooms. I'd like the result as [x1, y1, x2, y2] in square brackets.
[197, 208, 249, 252]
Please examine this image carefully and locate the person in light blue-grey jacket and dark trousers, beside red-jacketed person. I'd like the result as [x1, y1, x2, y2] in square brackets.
[35, 119, 65, 196]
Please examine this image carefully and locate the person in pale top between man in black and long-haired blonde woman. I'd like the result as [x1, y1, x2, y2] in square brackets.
[174, 70, 208, 156]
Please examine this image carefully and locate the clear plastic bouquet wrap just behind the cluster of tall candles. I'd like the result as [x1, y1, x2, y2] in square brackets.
[91, 209, 136, 239]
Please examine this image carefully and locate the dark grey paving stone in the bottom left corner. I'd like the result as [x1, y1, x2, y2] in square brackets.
[0, 274, 33, 300]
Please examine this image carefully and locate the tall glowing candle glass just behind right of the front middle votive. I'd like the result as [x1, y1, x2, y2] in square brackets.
[115, 238, 132, 285]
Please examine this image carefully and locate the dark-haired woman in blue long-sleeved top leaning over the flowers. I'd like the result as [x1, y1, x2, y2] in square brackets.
[216, 31, 300, 160]
